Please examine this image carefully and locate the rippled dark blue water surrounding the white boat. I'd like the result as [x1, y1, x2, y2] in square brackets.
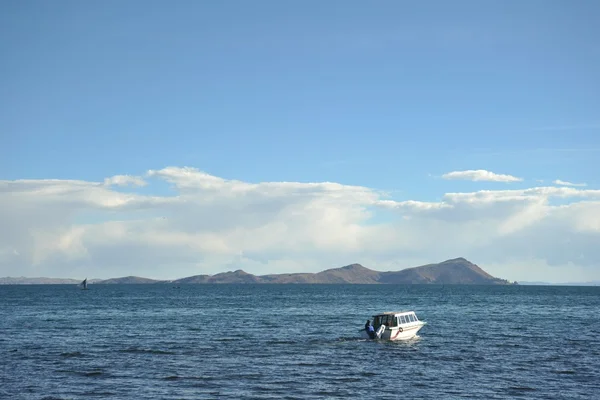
[0, 285, 600, 400]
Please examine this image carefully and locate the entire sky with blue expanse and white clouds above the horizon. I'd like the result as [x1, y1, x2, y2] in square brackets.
[0, 0, 600, 283]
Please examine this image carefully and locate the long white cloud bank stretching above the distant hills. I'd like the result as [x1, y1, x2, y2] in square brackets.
[0, 167, 600, 280]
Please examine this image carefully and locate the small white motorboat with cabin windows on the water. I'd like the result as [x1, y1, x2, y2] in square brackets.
[361, 311, 427, 340]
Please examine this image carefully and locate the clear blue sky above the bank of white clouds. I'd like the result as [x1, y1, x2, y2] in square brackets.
[0, 1, 600, 282]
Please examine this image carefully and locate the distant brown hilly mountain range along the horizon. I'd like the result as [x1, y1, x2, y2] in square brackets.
[0, 257, 516, 285]
